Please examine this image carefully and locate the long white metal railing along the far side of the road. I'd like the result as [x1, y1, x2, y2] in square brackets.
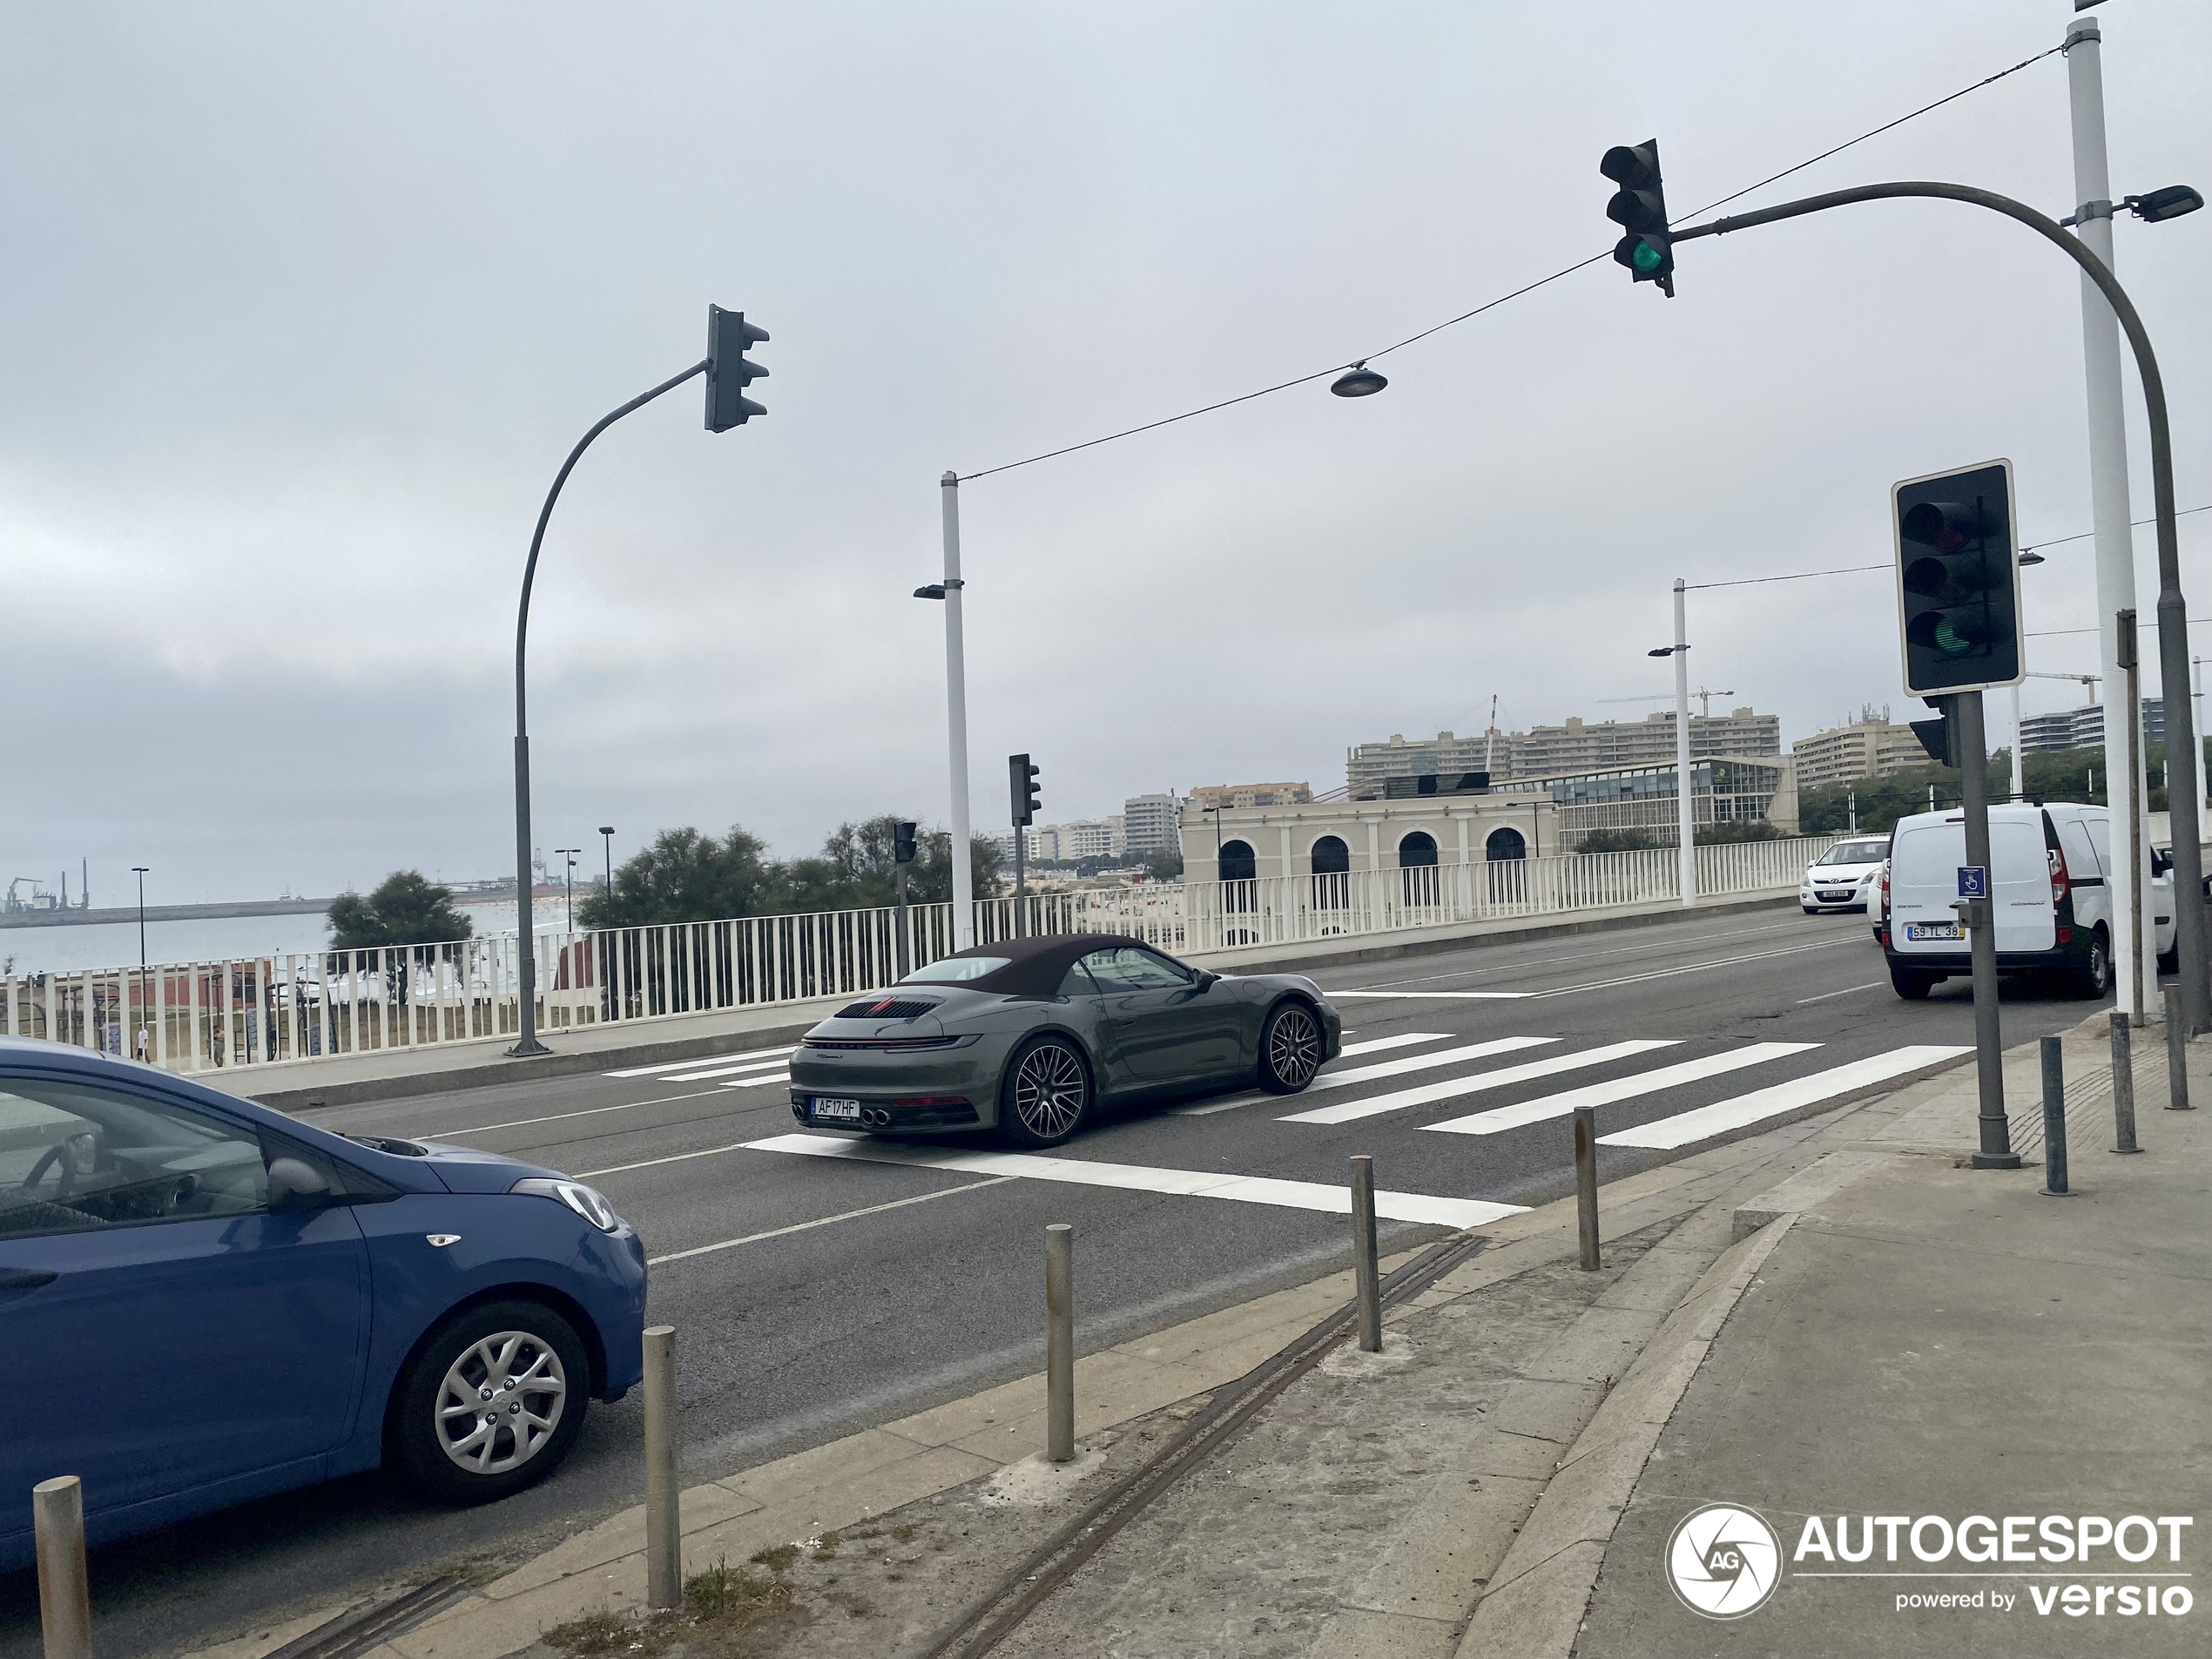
[0, 836, 1836, 1073]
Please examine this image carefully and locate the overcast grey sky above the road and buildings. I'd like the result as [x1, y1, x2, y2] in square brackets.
[0, 0, 2212, 902]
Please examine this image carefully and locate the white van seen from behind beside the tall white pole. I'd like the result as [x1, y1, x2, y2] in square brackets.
[1876, 803, 2175, 998]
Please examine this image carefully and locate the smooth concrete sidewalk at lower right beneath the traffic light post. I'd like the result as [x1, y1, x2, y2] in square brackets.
[1557, 1015, 2212, 1659]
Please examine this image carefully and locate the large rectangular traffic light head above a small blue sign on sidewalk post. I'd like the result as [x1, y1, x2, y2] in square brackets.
[1892, 460, 2024, 697]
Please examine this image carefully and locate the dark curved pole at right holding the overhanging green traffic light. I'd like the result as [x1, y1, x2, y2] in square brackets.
[1670, 179, 2208, 1035]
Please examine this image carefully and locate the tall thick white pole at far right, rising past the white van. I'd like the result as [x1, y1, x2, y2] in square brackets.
[2066, 17, 2159, 1024]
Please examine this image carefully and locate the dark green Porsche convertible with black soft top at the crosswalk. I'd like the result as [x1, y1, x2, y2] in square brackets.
[792, 934, 1345, 1146]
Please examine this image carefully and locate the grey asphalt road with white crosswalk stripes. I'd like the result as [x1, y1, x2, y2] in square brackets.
[0, 909, 2090, 1659]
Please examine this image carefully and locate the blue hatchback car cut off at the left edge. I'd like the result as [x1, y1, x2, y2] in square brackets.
[0, 1037, 646, 1568]
